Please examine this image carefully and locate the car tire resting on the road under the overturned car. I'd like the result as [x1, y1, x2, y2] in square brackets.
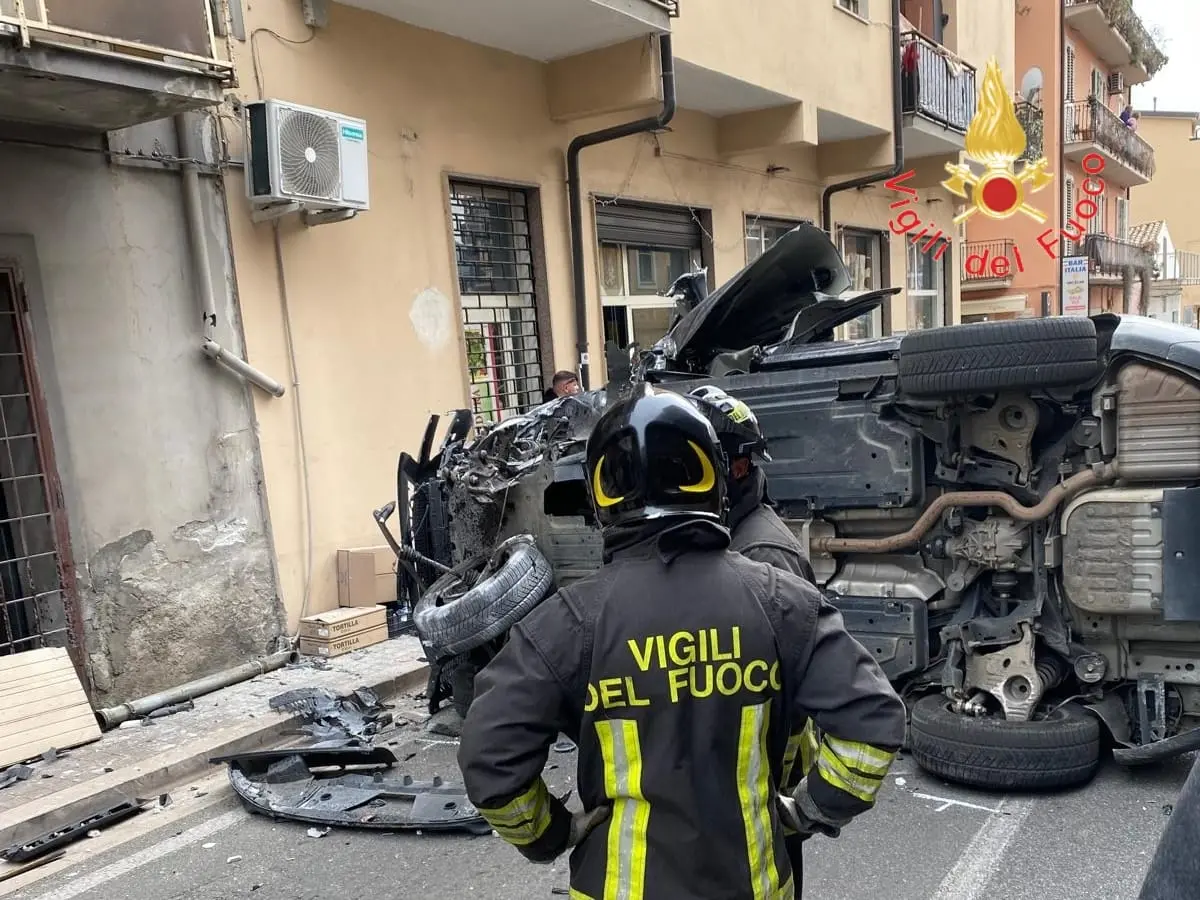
[910, 694, 1100, 791]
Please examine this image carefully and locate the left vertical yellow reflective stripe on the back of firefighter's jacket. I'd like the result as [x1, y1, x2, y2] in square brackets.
[597, 719, 650, 900]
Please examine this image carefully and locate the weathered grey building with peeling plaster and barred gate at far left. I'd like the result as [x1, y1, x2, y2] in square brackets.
[0, 0, 284, 702]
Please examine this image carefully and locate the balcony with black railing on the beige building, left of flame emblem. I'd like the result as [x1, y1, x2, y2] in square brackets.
[900, 31, 976, 160]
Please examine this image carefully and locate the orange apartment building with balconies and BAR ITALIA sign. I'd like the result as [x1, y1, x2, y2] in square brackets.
[962, 0, 1165, 320]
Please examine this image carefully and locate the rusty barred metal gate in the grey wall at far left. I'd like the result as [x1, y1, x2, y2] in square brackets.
[0, 268, 82, 664]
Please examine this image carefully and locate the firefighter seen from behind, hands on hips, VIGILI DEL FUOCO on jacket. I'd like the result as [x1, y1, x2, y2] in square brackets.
[458, 388, 905, 900]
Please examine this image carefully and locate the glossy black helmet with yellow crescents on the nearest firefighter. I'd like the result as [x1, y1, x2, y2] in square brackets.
[587, 384, 728, 528]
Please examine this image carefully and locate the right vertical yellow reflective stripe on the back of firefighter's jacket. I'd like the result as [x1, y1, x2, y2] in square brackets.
[738, 702, 780, 900]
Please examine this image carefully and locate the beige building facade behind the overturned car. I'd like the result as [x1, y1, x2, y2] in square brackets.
[226, 0, 1014, 626]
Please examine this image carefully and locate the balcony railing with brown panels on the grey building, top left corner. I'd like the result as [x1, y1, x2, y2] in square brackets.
[0, 0, 235, 84]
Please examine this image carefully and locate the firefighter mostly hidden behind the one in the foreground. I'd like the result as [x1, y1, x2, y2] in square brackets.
[689, 385, 816, 584]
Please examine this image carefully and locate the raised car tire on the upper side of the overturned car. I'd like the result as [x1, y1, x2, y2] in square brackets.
[899, 316, 1100, 396]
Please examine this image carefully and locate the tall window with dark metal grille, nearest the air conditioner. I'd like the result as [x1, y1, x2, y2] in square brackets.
[450, 181, 546, 428]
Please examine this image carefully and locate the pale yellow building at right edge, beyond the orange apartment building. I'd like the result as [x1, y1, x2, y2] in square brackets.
[1130, 109, 1200, 325]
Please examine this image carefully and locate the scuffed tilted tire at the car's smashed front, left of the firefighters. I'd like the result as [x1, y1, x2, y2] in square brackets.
[413, 535, 554, 656]
